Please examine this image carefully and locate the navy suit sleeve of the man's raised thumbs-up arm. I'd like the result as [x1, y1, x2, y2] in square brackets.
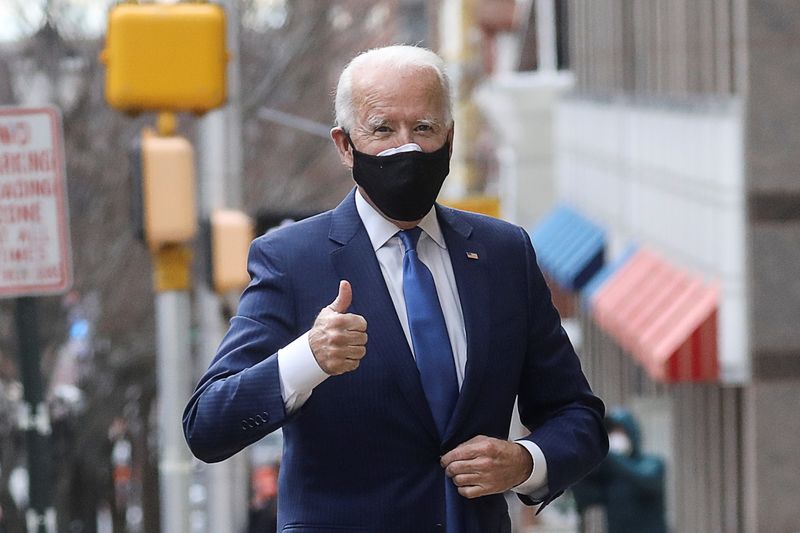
[183, 237, 297, 462]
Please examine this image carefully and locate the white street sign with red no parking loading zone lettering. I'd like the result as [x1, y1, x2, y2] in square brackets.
[0, 107, 72, 298]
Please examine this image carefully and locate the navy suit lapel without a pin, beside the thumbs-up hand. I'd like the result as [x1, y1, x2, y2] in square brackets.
[329, 189, 439, 442]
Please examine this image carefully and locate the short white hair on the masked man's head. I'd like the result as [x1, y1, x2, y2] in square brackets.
[334, 45, 453, 131]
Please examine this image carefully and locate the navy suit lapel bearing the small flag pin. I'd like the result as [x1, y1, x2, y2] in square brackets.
[438, 207, 490, 441]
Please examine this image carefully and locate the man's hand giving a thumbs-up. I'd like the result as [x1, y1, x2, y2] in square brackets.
[308, 280, 367, 376]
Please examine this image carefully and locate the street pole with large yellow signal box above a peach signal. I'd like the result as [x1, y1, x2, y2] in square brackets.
[100, 2, 228, 533]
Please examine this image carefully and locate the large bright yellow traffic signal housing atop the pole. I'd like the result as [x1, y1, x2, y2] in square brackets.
[100, 3, 228, 112]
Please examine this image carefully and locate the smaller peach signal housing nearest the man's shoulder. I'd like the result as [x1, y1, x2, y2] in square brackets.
[210, 209, 255, 293]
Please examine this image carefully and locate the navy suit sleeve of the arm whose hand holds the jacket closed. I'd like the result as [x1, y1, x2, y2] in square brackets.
[519, 228, 608, 506]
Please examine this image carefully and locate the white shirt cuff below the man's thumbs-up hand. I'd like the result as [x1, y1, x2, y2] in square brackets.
[278, 332, 329, 415]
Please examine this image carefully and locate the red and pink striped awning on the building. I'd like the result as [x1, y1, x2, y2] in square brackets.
[590, 249, 719, 382]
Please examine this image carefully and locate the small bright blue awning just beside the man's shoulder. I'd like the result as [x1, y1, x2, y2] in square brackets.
[531, 205, 606, 292]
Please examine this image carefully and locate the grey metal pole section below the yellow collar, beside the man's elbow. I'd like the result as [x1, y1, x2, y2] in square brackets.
[156, 290, 192, 533]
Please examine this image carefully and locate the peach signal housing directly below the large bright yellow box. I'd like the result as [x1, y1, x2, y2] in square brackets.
[140, 130, 197, 250]
